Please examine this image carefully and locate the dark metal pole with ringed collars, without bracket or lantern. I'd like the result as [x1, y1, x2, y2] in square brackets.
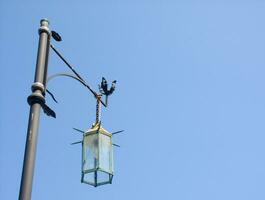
[19, 19, 50, 200]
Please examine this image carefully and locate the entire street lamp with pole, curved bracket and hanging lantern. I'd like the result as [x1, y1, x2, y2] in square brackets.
[19, 19, 122, 200]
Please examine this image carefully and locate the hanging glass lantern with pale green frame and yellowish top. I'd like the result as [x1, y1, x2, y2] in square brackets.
[81, 123, 113, 187]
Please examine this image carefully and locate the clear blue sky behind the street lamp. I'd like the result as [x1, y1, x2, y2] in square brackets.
[0, 0, 265, 200]
